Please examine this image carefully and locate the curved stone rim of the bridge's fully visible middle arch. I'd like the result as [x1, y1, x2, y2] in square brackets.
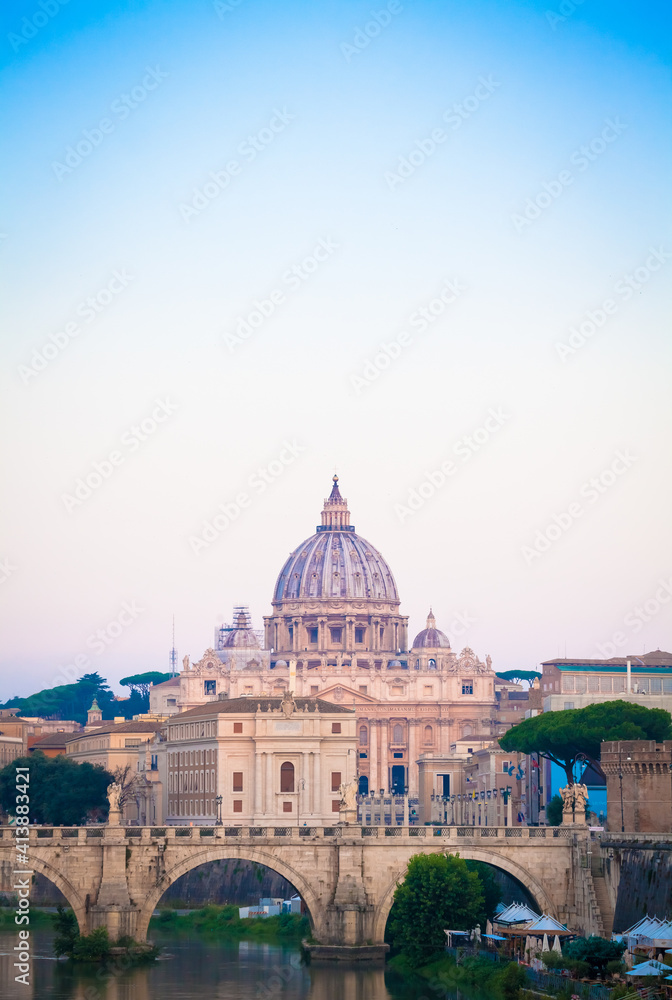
[136, 845, 323, 941]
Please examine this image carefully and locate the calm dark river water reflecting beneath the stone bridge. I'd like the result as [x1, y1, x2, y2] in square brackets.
[0, 928, 494, 1000]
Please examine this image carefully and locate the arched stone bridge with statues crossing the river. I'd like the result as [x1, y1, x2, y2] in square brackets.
[0, 826, 602, 957]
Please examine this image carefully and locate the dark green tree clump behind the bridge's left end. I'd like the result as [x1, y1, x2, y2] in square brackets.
[0, 750, 112, 826]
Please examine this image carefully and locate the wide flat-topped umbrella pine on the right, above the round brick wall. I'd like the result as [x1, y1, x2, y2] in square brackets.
[499, 701, 672, 785]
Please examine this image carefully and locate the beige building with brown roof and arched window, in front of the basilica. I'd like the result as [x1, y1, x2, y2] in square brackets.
[165, 693, 357, 827]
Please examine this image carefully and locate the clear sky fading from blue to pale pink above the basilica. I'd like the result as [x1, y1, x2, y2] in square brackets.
[0, 0, 672, 700]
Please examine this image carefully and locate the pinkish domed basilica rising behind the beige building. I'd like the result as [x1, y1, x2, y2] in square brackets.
[150, 477, 497, 796]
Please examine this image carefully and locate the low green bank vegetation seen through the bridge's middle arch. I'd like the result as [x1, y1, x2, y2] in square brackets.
[149, 904, 310, 941]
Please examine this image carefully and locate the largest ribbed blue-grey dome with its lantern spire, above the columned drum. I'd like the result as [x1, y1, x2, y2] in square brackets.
[273, 476, 399, 604]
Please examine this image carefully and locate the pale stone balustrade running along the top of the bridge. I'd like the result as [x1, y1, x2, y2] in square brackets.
[0, 824, 576, 846]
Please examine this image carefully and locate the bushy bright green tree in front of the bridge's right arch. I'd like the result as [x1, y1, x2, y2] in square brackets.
[388, 854, 486, 967]
